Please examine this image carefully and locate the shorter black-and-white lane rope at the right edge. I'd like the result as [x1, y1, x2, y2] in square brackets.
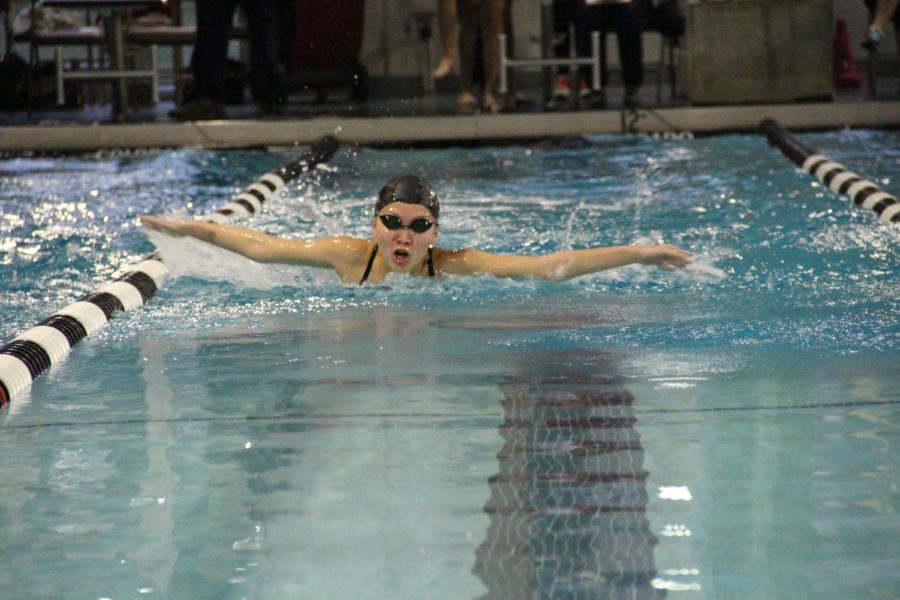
[759, 119, 900, 223]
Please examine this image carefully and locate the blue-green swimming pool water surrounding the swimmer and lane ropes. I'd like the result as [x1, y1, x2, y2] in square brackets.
[0, 131, 900, 599]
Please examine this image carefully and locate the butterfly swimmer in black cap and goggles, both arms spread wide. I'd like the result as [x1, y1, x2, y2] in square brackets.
[141, 175, 691, 285]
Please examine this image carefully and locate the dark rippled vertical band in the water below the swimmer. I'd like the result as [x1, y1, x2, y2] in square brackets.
[475, 352, 665, 599]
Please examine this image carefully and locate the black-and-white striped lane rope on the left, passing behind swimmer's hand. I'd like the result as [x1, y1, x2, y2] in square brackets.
[0, 136, 339, 407]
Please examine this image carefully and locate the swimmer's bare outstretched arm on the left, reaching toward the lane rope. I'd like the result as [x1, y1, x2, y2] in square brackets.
[141, 215, 366, 276]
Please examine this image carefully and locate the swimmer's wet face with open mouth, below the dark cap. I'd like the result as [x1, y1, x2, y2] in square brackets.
[372, 202, 438, 273]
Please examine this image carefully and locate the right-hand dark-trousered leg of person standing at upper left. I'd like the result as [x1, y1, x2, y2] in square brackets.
[240, 0, 285, 110]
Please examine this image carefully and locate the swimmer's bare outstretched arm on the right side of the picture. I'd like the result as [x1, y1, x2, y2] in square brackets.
[440, 244, 692, 281]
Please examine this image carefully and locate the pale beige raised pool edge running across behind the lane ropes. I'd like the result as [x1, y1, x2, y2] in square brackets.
[0, 101, 900, 153]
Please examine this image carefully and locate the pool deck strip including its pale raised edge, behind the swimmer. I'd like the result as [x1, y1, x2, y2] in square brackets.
[0, 85, 900, 154]
